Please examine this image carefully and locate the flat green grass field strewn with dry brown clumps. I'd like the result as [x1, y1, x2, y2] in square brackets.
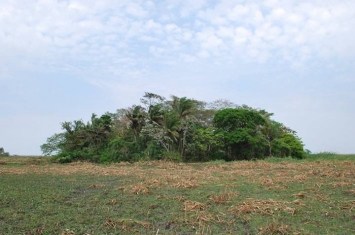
[0, 155, 355, 235]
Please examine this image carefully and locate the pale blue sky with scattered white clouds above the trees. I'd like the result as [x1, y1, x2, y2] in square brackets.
[0, 0, 355, 155]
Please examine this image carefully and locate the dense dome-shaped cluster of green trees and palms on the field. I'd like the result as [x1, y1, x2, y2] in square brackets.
[41, 93, 305, 162]
